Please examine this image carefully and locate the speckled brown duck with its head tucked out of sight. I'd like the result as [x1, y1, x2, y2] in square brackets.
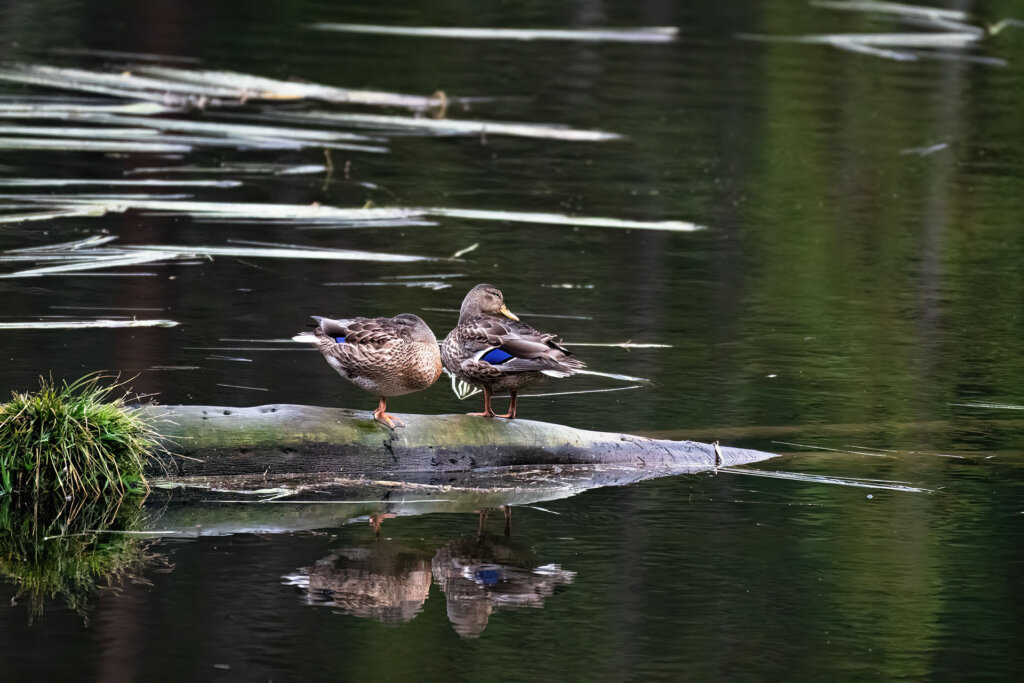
[301, 313, 441, 429]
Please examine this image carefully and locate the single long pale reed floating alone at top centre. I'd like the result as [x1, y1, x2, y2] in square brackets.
[309, 22, 679, 43]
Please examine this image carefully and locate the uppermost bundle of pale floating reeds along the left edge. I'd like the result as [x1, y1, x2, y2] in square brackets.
[0, 63, 622, 146]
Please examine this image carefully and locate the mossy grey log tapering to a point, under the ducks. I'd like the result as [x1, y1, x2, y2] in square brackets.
[140, 404, 772, 478]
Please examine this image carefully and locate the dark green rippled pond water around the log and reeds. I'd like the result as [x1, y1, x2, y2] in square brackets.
[0, 1, 1024, 681]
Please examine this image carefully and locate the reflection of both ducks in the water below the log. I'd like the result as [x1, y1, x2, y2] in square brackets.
[285, 511, 575, 638]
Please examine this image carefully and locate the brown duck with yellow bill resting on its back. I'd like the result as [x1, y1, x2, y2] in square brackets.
[441, 285, 584, 419]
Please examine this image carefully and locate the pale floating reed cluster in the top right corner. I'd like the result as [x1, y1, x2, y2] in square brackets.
[737, 0, 1024, 66]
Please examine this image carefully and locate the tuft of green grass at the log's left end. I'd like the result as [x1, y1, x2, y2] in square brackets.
[0, 374, 158, 499]
